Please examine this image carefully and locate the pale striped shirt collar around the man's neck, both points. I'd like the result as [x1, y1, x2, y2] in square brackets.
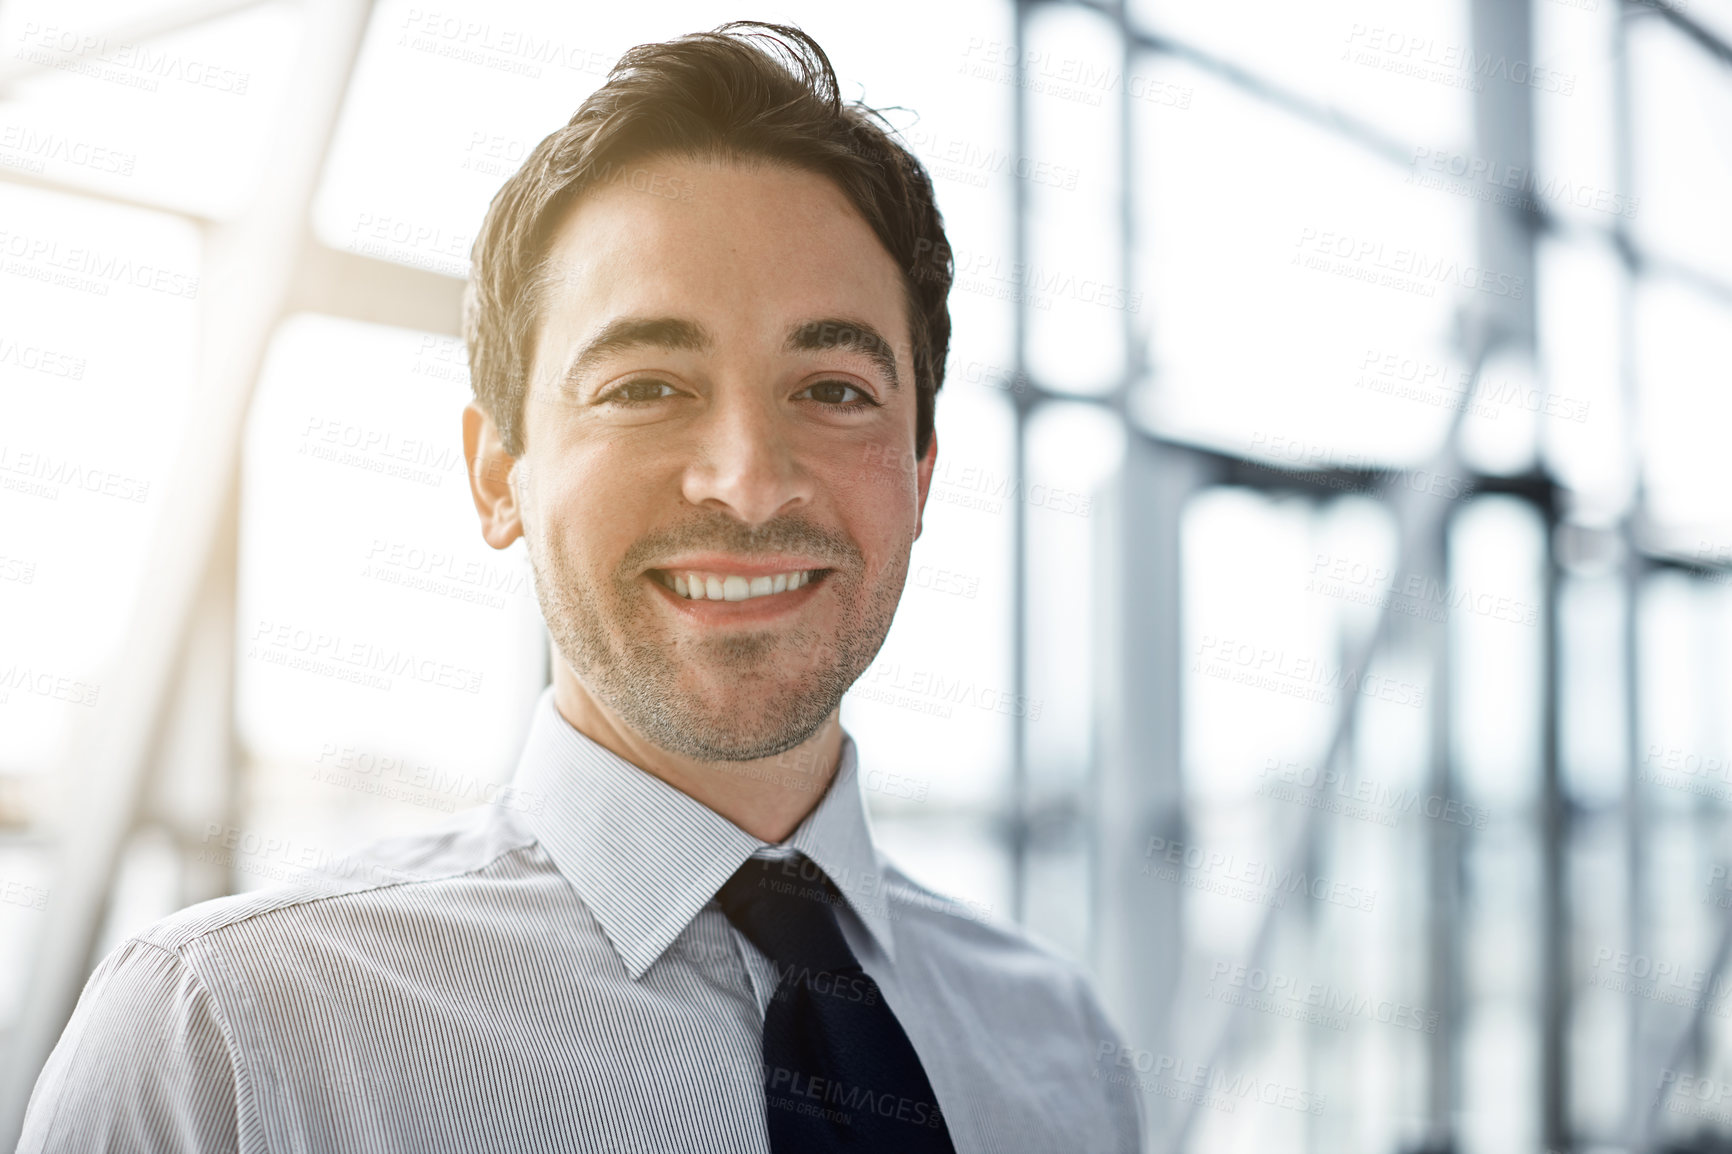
[511, 688, 895, 979]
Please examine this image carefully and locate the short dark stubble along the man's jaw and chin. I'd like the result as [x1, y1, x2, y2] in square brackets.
[528, 516, 911, 762]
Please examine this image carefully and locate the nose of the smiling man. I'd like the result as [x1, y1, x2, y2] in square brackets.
[681, 388, 812, 525]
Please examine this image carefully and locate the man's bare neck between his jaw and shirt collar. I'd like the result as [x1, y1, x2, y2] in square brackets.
[553, 652, 842, 842]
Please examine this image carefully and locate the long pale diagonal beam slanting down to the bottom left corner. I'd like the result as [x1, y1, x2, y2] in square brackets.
[0, 0, 369, 1147]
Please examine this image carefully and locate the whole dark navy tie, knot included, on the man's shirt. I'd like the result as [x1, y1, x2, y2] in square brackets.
[715, 858, 956, 1154]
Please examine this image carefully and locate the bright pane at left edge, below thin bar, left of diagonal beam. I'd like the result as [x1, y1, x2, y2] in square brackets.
[0, 185, 204, 772]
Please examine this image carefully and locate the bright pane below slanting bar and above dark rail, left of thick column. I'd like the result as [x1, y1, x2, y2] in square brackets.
[1136, 53, 1475, 468]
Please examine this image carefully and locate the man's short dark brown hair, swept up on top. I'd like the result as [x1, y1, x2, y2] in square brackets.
[462, 21, 954, 456]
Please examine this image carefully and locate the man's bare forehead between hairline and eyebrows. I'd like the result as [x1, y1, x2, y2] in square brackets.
[537, 156, 908, 362]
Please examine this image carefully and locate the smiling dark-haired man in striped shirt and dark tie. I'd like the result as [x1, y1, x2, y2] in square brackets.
[23, 26, 1140, 1154]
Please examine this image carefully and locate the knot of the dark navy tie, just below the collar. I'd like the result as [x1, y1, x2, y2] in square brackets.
[715, 854, 859, 972]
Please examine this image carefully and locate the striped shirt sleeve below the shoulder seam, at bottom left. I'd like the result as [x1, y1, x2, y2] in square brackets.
[17, 939, 239, 1154]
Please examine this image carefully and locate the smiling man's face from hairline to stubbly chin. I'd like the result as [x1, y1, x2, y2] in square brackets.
[498, 158, 935, 761]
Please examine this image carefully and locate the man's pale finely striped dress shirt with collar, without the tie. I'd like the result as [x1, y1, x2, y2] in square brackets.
[19, 691, 1141, 1154]
